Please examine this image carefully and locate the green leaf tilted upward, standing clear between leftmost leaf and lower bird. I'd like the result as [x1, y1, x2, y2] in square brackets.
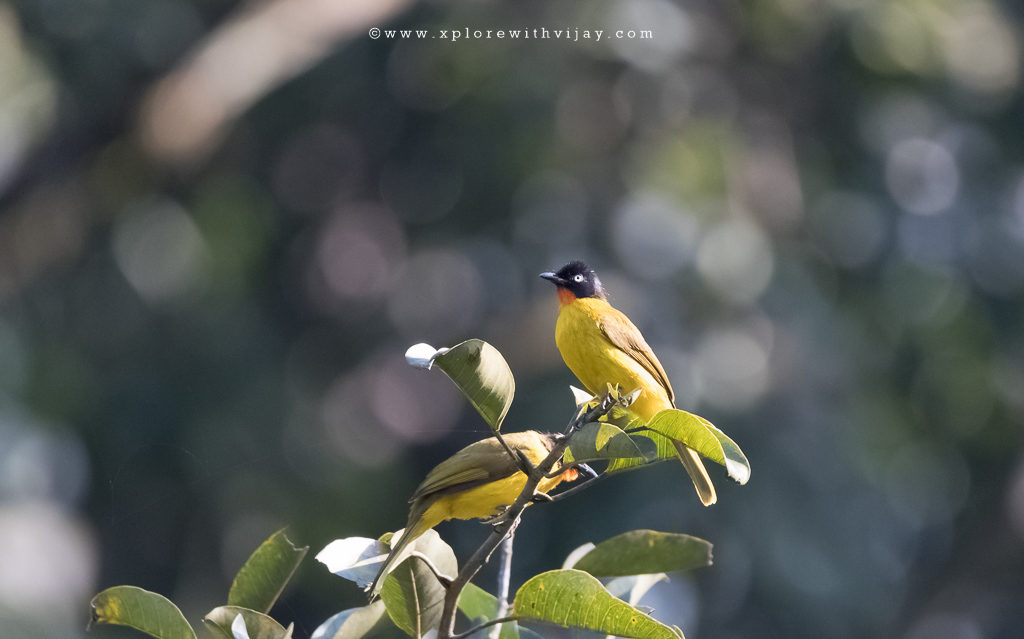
[227, 529, 309, 612]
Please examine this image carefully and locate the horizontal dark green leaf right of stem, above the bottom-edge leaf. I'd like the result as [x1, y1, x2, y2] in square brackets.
[574, 530, 712, 577]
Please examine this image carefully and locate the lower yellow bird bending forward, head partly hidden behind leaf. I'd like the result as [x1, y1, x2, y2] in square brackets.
[370, 430, 579, 597]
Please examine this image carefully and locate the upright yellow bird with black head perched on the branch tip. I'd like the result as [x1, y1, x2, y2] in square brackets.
[541, 261, 718, 506]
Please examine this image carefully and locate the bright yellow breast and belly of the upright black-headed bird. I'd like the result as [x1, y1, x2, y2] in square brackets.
[555, 298, 672, 420]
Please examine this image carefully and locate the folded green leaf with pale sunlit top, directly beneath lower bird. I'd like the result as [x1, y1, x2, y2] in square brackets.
[380, 530, 459, 637]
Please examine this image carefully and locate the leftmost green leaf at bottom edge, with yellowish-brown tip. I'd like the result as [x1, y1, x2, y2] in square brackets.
[89, 586, 196, 639]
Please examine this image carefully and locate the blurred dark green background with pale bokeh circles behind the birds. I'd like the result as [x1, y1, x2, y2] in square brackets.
[0, 0, 1024, 639]
